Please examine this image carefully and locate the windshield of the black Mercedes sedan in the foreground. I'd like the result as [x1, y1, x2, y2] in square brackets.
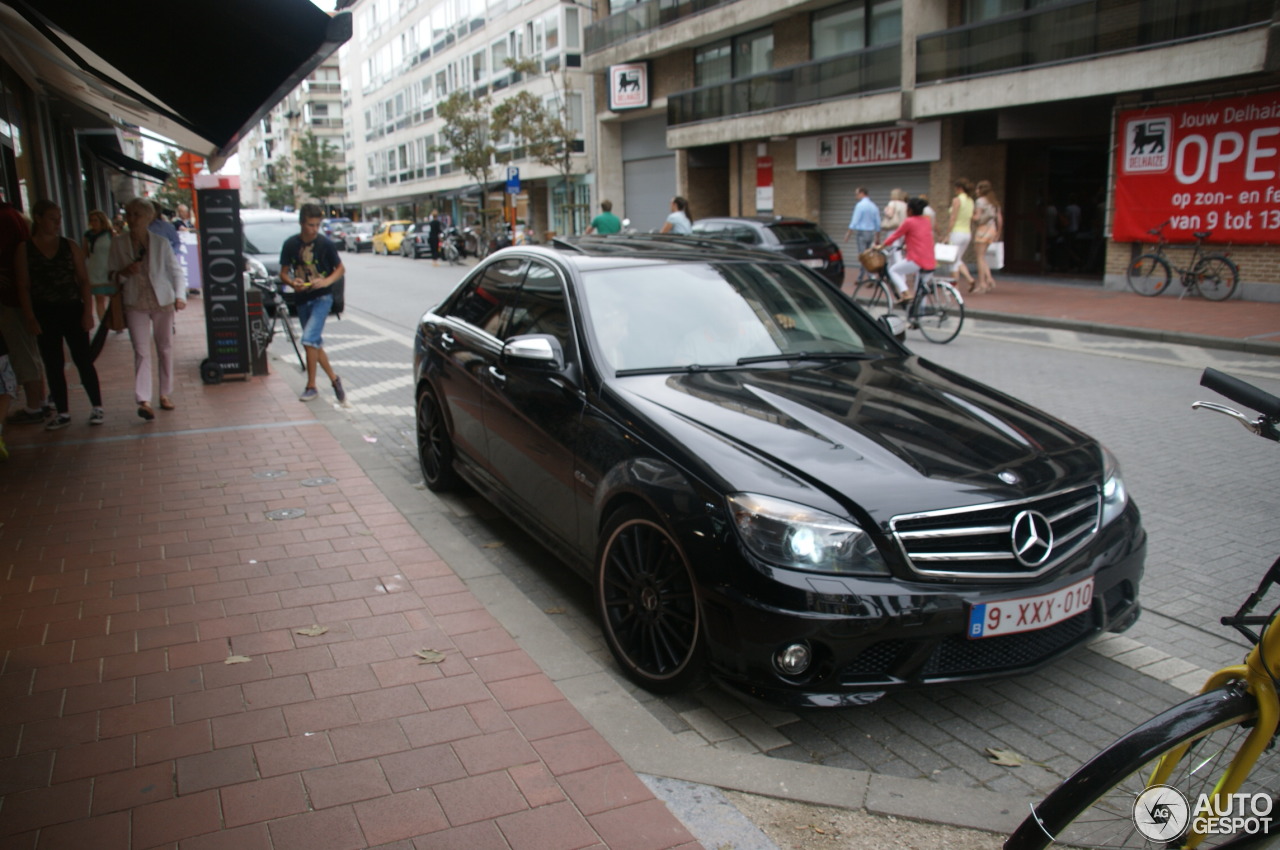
[582, 262, 897, 373]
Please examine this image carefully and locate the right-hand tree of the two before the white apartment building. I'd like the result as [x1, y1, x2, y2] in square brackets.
[493, 59, 577, 232]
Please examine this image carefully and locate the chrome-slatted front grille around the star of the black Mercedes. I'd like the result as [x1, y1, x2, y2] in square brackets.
[890, 485, 1102, 580]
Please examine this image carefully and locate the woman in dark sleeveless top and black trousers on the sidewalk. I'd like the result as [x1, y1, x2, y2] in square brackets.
[14, 201, 104, 431]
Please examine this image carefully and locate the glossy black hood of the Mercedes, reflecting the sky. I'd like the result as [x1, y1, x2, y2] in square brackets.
[613, 357, 1102, 522]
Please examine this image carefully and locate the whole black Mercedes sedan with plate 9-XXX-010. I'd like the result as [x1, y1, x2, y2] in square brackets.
[413, 236, 1146, 707]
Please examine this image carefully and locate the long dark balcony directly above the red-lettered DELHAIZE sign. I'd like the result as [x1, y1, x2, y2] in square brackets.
[667, 42, 902, 127]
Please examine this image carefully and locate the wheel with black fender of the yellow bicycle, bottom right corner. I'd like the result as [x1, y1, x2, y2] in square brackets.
[1005, 686, 1280, 850]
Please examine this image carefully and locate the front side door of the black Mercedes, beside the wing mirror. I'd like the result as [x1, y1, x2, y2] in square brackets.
[484, 260, 585, 543]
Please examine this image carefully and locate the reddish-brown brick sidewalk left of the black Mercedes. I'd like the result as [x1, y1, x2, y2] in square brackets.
[0, 308, 696, 849]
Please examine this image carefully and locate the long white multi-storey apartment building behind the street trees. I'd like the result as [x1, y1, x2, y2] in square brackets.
[342, 0, 594, 233]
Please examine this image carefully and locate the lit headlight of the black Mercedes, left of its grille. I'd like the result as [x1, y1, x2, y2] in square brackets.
[728, 493, 888, 576]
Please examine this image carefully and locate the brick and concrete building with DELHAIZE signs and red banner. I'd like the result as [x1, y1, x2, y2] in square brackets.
[584, 0, 1280, 301]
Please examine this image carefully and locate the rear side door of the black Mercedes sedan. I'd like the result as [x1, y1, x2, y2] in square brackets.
[430, 257, 529, 470]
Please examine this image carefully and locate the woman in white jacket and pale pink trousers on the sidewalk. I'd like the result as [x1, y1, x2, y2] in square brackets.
[110, 197, 187, 422]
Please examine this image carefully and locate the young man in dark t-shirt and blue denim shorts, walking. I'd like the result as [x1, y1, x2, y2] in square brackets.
[280, 204, 347, 405]
